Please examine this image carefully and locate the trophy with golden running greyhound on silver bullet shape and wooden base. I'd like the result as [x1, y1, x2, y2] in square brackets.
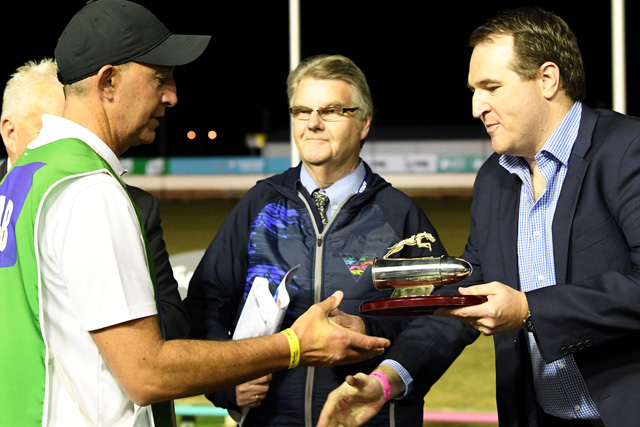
[360, 232, 486, 316]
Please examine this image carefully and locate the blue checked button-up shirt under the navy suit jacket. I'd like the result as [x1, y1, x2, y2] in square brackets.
[500, 102, 600, 419]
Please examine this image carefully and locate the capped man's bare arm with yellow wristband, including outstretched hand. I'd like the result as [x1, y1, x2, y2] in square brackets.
[90, 292, 389, 406]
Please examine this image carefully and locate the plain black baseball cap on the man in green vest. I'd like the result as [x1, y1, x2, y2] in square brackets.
[55, 0, 211, 84]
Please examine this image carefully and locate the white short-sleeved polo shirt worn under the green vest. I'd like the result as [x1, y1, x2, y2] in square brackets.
[29, 115, 157, 427]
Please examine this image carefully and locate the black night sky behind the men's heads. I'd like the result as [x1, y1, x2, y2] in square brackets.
[0, 0, 640, 157]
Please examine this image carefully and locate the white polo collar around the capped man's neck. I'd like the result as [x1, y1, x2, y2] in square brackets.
[27, 114, 125, 176]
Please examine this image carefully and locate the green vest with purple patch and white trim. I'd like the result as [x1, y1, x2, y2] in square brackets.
[0, 139, 155, 427]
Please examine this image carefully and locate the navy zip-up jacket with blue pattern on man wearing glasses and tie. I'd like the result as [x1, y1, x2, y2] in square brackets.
[185, 163, 446, 427]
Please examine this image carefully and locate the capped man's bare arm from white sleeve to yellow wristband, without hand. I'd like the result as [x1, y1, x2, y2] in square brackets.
[91, 318, 290, 406]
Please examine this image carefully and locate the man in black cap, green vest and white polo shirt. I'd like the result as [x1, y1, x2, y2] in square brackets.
[0, 0, 389, 426]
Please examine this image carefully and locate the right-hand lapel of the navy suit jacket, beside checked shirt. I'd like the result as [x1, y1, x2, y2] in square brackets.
[552, 104, 599, 284]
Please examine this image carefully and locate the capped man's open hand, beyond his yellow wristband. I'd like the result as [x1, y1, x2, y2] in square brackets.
[291, 291, 390, 367]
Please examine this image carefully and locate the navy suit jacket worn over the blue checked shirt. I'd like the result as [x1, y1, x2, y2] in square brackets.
[391, 106, 640, 426]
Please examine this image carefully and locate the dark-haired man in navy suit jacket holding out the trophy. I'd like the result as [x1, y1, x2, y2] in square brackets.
[319, 9, 640, 426]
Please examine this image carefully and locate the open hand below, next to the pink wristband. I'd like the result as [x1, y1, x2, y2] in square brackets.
[318, 373, 385, 427]
